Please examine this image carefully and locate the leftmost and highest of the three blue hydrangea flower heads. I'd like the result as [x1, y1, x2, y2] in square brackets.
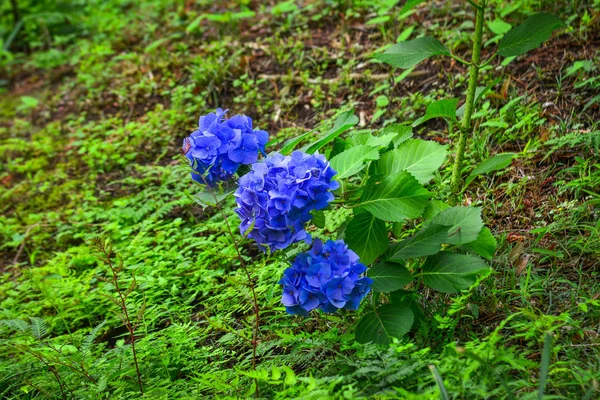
[182, 108, 269, 186]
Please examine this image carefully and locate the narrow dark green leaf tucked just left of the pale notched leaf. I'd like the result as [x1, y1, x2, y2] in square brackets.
[389, 224, 450, 260]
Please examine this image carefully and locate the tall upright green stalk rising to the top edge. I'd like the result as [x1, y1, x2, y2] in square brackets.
[452, 0, 486, 194]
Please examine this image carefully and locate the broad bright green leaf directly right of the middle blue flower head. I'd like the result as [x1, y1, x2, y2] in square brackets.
[359, 171, 431, 221]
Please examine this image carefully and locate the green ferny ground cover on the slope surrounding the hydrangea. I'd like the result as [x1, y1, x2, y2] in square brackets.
[0, 0, 600, 399]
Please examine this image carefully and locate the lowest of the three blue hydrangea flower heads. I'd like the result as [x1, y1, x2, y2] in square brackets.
[279, 239, 373, 315]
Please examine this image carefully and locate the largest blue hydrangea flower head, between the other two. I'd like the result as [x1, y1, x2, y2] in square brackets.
[235, 151, 339, 251]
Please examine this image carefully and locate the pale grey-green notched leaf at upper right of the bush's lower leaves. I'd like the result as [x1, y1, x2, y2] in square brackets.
[432, 206, 483, 244]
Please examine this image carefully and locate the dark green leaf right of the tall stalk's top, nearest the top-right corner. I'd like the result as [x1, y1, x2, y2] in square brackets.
[498, 13, 564, 57]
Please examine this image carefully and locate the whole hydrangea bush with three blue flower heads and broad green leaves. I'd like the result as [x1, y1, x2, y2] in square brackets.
[183, 109, 496, 344]
